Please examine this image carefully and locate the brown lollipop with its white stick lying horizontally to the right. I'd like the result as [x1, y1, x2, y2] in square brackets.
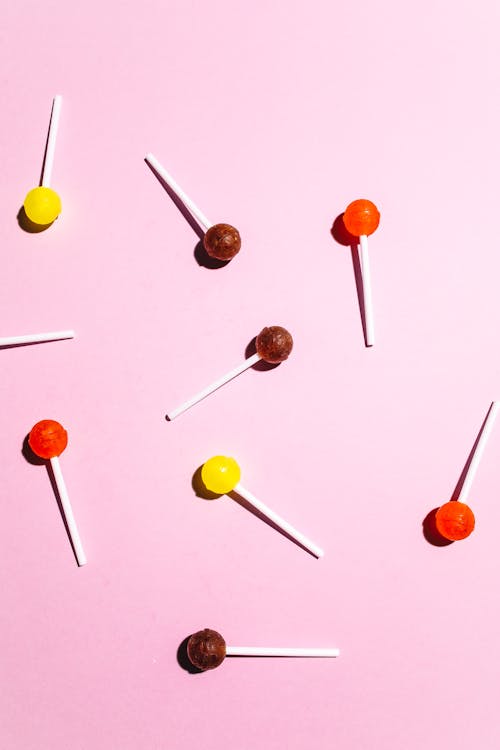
[187, 628, 340, 672]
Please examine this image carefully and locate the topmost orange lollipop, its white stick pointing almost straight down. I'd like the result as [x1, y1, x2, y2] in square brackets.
[344, 199, 380, 346]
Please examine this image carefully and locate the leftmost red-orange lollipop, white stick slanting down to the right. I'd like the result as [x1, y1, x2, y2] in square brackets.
[28, 419, 87, 566]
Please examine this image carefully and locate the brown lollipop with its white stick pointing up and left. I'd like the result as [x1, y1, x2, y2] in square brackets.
[146, 154, 241, 260]
